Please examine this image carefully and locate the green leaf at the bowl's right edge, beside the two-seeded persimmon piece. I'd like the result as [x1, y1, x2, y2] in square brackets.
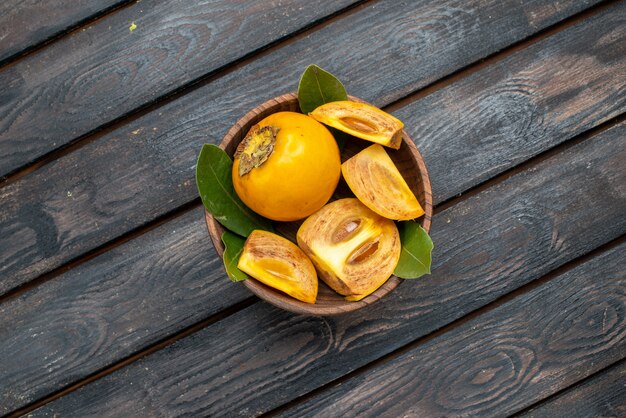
[393, 221, 433, 279]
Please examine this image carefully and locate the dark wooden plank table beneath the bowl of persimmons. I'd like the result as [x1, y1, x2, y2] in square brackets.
[0, 0, 626, 417]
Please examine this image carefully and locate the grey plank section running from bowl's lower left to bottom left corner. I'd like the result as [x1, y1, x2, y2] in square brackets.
[0, 208, 250, 415]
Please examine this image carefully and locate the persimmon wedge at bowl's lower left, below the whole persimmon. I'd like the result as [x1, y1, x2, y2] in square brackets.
[237, 230, 317, 303]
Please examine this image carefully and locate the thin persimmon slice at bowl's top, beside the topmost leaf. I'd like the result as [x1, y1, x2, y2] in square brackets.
[309, 100, 404, 149]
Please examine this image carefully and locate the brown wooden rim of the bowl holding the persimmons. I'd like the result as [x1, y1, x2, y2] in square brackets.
[204, 92, 433, 316]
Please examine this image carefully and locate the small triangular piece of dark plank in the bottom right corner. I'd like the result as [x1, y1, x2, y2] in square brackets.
[516, 360, 626, 418]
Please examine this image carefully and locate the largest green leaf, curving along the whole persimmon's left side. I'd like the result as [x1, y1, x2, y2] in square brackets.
[196, 144, 274, 237]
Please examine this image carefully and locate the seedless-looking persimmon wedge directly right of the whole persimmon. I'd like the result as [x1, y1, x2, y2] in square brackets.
[341, 144, 424, 220]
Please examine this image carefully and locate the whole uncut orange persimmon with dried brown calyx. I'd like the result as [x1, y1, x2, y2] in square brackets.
[232, 112, 341, 221]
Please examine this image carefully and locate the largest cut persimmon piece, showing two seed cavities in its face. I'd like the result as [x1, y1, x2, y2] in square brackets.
[297, 198, 401, 300]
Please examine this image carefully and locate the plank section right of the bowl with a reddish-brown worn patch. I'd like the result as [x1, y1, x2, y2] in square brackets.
[395, 3, 626, 202]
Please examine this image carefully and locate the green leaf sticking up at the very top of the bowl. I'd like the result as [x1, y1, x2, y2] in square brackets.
[298, 64, 348, 115]
